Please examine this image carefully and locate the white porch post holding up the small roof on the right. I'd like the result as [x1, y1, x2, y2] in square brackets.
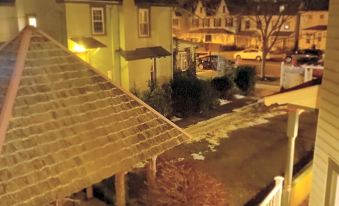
[282, 106, 303, 206]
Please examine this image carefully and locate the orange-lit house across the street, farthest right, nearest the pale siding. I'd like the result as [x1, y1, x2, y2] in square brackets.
[299, 10, 328, 50]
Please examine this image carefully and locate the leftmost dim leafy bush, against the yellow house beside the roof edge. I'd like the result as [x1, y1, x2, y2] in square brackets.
[141, 84, 172, 117]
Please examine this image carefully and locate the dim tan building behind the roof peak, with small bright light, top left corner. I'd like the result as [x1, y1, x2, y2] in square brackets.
[0, 0, 67, 45]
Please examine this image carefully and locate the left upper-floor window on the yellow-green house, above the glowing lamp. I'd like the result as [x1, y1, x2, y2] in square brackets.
[91, 7, 106, 35]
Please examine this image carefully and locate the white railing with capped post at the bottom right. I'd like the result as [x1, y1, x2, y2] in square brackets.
[260, 176, 284, 206]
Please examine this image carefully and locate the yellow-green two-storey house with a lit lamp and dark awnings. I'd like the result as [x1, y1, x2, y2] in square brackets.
[63, 0, 176, 91]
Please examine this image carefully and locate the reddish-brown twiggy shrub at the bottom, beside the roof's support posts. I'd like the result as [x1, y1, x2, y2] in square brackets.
[144, 161, 228, 206]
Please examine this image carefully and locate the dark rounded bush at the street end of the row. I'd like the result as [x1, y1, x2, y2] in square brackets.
[234, 66, 256, 95]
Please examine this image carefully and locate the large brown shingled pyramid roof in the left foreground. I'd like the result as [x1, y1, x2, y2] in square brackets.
[0, 27, 189, 206]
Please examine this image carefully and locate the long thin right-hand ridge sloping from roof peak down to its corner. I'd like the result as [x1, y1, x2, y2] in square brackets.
[33, 27, 191, 142]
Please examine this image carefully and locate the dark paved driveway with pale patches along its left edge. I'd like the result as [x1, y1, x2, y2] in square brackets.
[165, 106, 317, 206]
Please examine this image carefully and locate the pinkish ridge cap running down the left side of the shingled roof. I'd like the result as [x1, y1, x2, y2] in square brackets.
[0, 26, 32, 152]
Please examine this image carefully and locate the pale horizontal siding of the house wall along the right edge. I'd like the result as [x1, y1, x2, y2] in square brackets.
[310, 0, 339, 206]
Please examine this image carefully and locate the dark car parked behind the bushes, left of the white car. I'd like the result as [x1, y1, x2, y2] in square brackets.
[198, 55, 235, 70]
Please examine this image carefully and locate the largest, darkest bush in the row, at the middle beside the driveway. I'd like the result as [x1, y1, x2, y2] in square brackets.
[171, 75, 217, 116]
